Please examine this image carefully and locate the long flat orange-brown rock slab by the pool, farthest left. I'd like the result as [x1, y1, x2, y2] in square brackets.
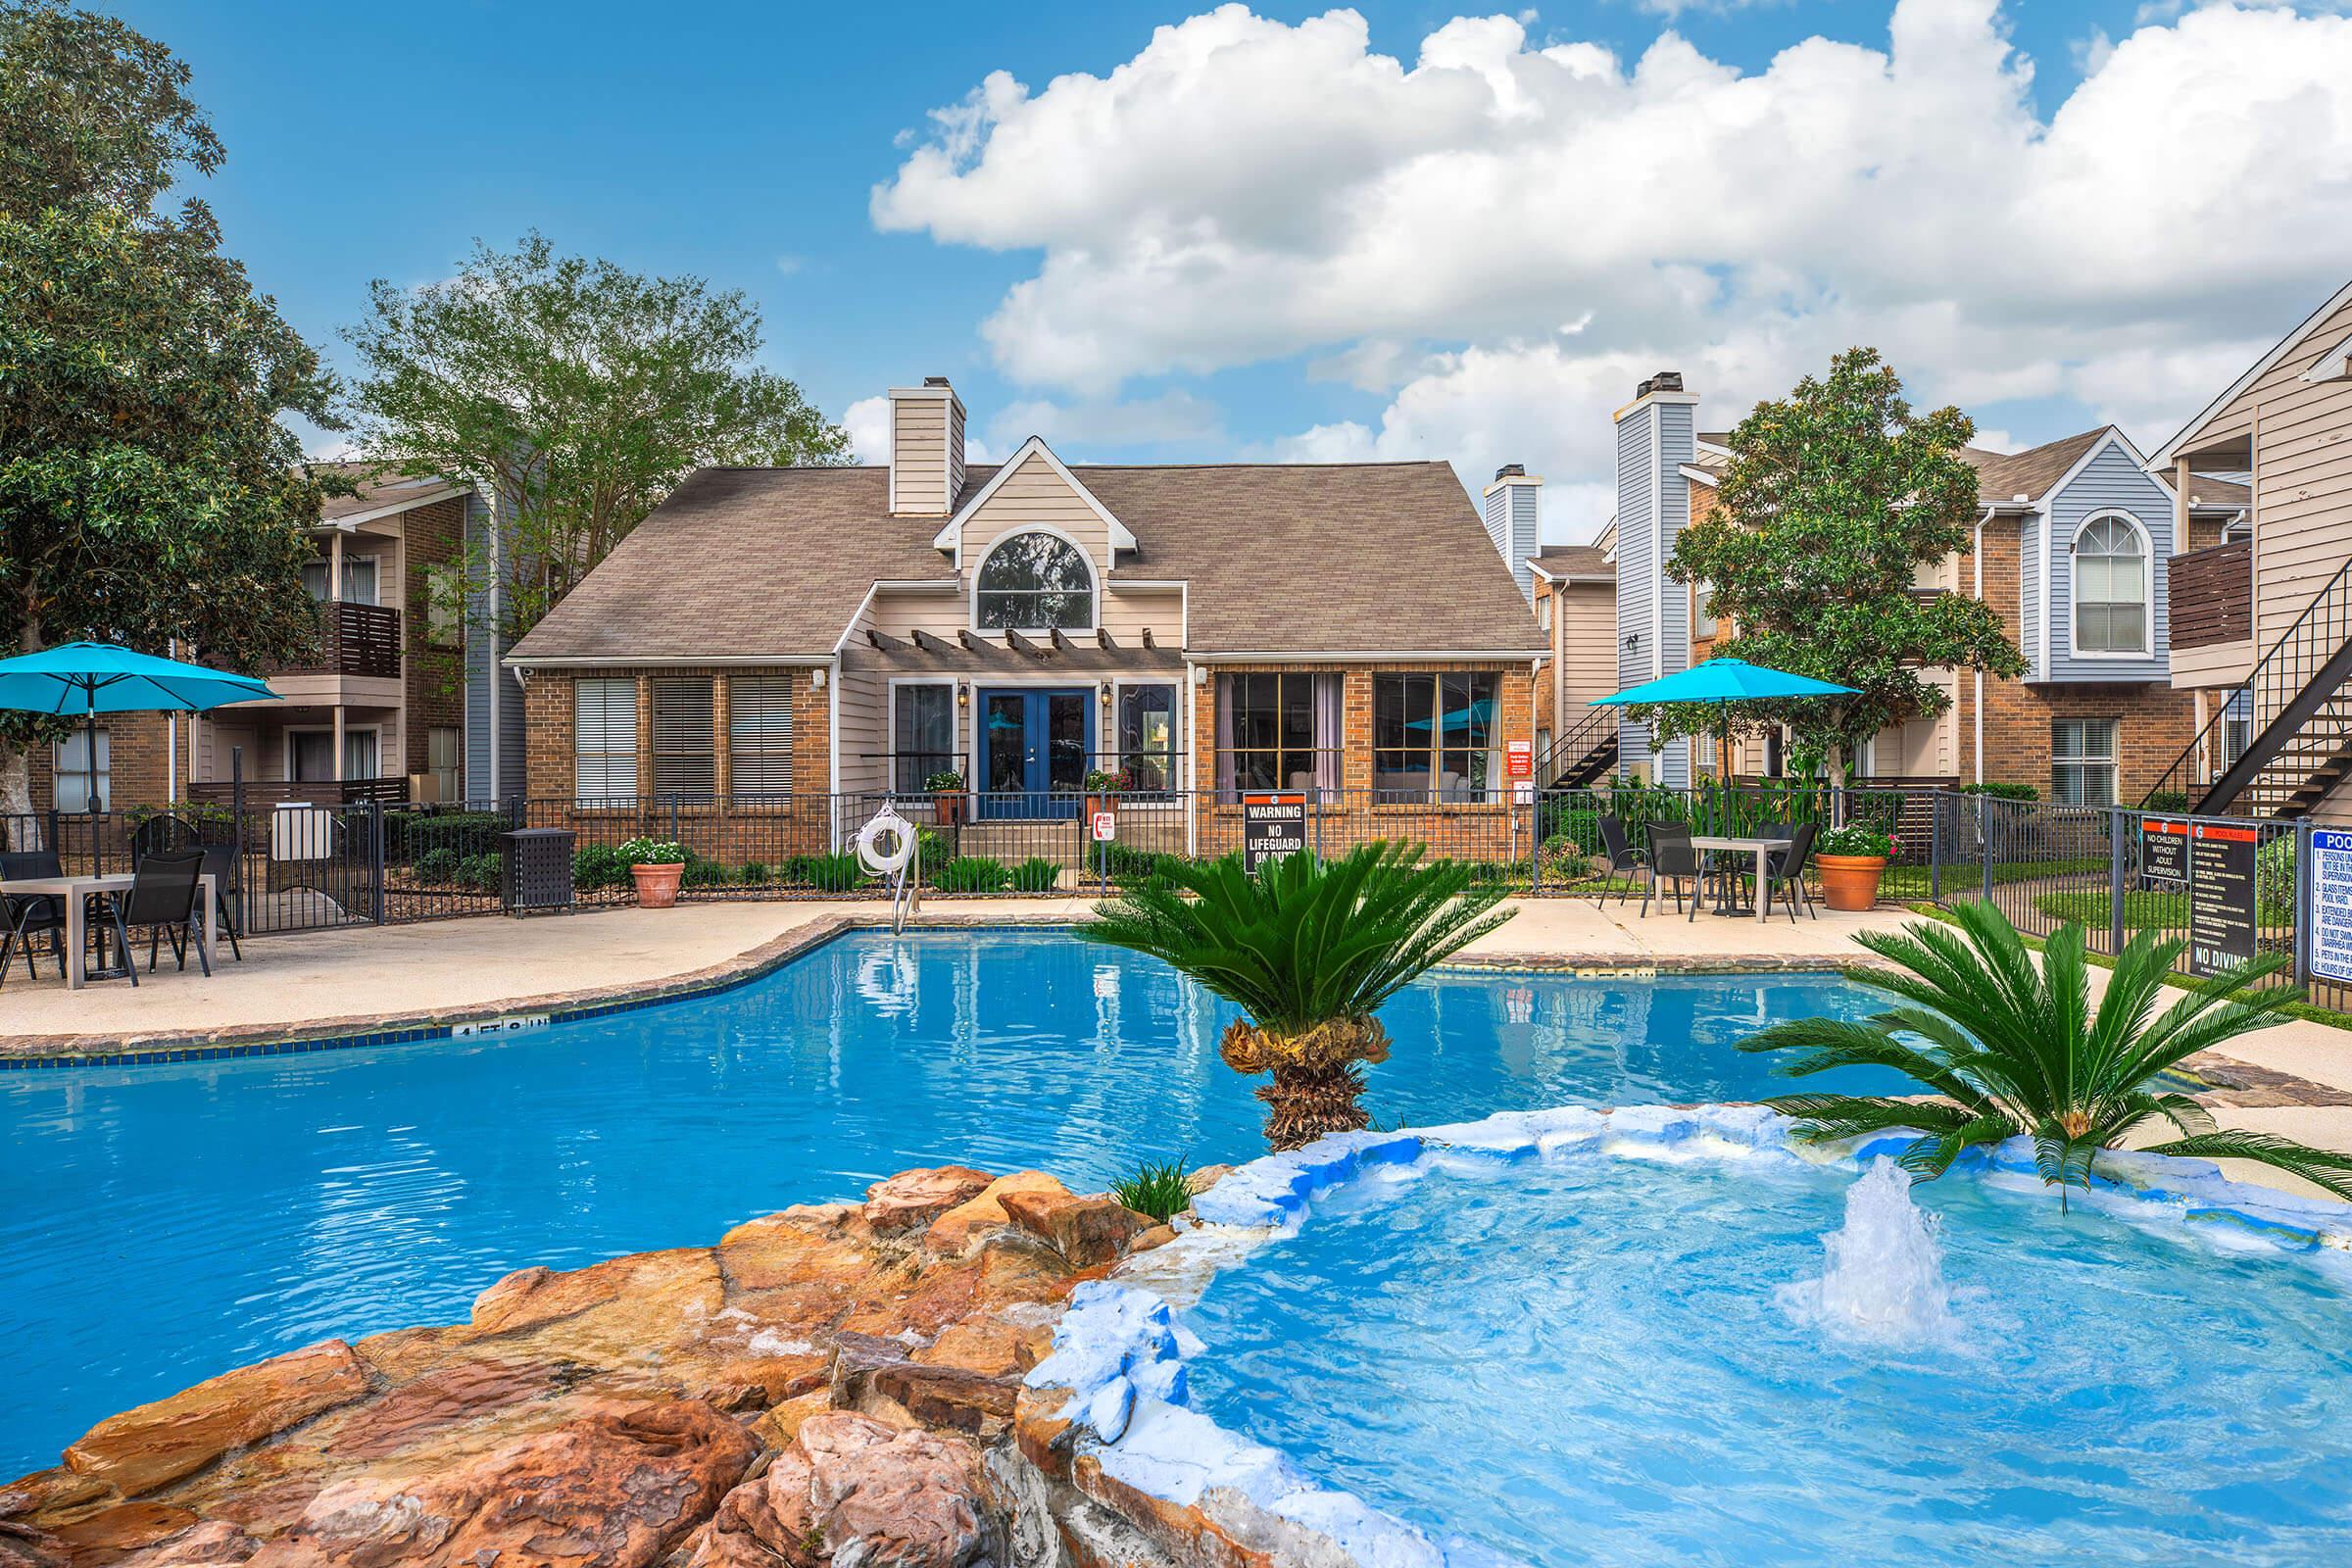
[66, 1340, 369, 1497]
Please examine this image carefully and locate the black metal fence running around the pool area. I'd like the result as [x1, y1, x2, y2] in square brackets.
[0, 783, 2352, 1006]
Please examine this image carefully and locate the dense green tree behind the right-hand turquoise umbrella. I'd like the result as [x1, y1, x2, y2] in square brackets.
[1637, 348, 2025, 780]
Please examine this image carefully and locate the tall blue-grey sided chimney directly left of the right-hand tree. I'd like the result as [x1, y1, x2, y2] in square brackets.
[1616, 369, 1698, 788]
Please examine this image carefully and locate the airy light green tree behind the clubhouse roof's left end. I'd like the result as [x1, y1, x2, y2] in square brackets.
[343, 232, 849, 632]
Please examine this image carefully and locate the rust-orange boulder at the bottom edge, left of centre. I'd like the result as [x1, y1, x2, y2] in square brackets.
[249, 1398, 758, 1568]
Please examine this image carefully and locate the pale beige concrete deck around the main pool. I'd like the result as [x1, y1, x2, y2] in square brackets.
[14, 898, 2352, 1192]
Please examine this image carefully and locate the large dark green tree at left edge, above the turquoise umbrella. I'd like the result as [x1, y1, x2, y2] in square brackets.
[0, 0, 334, 811]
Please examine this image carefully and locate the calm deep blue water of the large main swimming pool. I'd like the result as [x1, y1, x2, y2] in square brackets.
[0, 931, 1893, 1476]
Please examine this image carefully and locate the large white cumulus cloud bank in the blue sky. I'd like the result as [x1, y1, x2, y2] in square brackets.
[874, 0, 2352, 540]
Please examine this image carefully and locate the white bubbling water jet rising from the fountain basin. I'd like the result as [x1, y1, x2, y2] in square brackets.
[1778, 1154, 1952, 1345]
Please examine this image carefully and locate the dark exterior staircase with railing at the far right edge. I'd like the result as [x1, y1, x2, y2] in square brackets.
[2140, 550, 2352, 818]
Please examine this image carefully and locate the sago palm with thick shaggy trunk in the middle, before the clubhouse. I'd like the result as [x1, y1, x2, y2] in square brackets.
[1077, 842, 1510, 1150]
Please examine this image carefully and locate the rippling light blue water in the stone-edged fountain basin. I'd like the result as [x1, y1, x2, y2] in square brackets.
[1186, 1156, 2352, 1568]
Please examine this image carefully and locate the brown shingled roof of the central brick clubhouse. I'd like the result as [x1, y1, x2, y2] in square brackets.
[515, 464, 1543, 662]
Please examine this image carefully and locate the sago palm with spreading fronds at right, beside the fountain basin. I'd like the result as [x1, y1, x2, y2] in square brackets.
[1740, 901, 2352, 1203]
